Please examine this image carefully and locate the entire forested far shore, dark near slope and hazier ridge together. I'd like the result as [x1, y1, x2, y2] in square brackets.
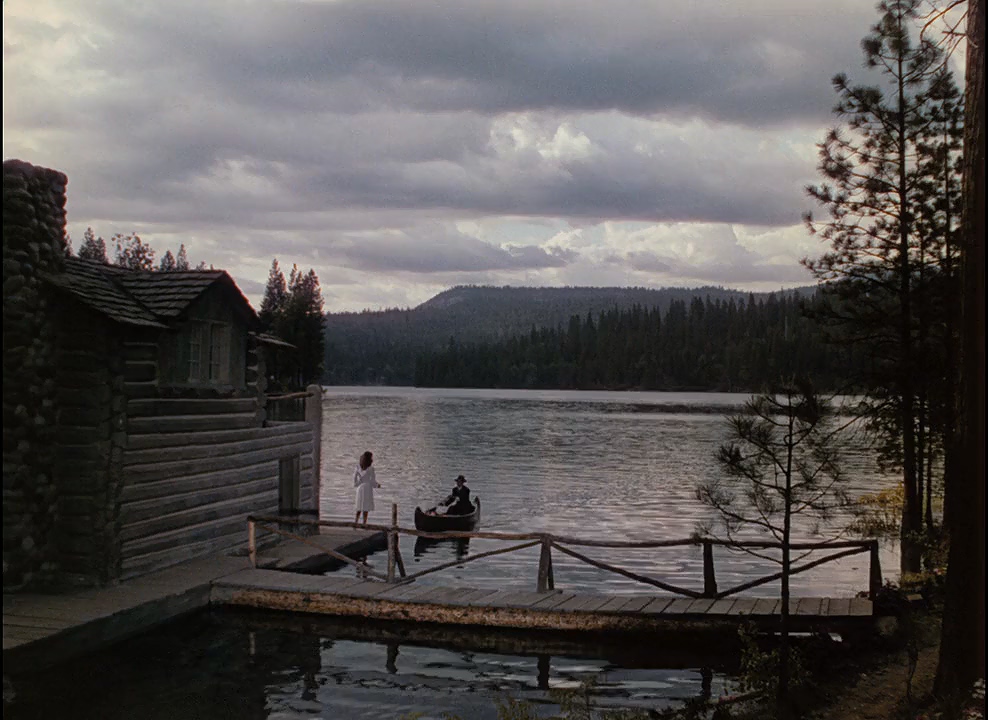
[324, 287, 850, 392]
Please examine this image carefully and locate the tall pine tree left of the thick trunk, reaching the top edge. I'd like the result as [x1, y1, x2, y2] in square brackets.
[804, 0, 942, 572]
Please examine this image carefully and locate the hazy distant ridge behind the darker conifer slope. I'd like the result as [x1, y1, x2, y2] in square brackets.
[324, 285, 816, 385]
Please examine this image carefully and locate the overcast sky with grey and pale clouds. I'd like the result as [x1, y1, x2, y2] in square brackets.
[3, 0, 940, 311]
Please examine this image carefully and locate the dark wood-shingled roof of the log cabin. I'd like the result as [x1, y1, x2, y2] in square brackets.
[48, 258, 257, 328]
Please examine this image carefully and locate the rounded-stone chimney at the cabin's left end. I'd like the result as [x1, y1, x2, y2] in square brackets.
[3, 160, 67, 592]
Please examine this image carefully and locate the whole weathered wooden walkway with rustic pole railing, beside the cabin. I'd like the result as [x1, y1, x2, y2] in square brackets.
[3, 508, 881, 672]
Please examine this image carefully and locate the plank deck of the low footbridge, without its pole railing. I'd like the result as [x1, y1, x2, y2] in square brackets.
[211, 569, 872, 633]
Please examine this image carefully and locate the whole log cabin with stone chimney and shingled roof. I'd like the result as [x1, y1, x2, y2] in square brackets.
[3, 161, 320, 592]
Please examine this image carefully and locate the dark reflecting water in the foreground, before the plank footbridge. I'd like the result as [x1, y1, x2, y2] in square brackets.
[4, 612, 736, 720]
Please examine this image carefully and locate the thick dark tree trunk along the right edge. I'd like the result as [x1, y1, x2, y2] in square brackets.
[936, 0, 985, 708]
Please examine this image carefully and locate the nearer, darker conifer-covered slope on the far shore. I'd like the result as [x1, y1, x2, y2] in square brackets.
[415, 294, 846, 391]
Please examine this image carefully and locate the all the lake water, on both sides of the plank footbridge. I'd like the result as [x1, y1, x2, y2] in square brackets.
[4, 387, 898, 720]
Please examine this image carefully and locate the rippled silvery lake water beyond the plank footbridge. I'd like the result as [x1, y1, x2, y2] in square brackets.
[322, 387, 897, 596]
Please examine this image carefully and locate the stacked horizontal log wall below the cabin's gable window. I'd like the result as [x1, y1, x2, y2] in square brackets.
[119, 397, 315, 578]
